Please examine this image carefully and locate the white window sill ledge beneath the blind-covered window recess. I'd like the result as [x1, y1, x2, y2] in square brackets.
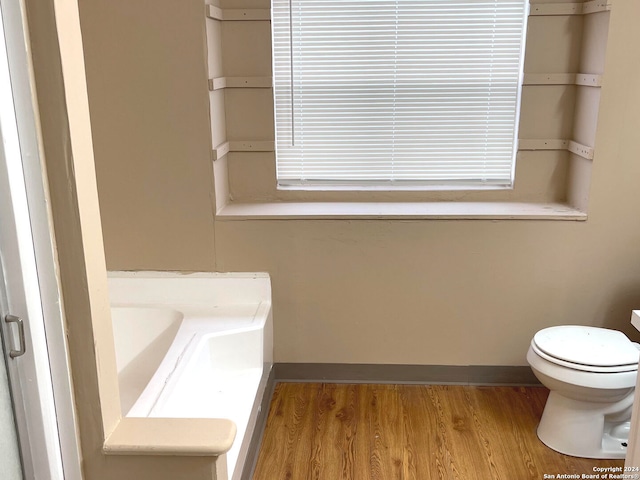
[216, 202, 587, 221]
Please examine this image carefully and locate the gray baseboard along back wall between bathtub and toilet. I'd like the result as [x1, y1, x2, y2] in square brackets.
[273, 363, 540, 386]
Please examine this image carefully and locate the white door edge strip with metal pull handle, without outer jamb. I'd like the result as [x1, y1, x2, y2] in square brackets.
[0, 8, 63, 480]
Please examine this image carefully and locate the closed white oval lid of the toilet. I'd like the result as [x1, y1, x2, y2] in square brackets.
[533, 325, 640, 367]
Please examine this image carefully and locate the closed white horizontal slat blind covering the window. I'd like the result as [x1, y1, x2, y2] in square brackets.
[272, 0, 527, 188]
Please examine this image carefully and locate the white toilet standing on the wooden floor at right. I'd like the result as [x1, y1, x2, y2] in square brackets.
[527, 325, 640, 459]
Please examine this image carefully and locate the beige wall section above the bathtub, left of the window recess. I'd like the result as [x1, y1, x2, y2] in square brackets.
[78, 0, 214, 270]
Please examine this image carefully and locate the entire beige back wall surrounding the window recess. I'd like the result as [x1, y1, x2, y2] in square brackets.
[80, 0, 640, 365]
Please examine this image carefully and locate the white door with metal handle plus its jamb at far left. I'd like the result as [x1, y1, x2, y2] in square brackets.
[0, 0, 81, 480]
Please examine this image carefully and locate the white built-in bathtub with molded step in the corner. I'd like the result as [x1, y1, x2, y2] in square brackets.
[109, 272, 273, 480]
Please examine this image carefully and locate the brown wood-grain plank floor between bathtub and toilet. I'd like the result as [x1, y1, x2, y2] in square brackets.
[253, 383, 624, 480]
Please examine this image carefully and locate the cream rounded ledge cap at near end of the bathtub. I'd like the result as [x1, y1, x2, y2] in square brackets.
[103, 417, 236, 457]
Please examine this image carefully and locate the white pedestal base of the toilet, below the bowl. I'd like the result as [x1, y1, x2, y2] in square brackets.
[538, 391, 634, 459]
